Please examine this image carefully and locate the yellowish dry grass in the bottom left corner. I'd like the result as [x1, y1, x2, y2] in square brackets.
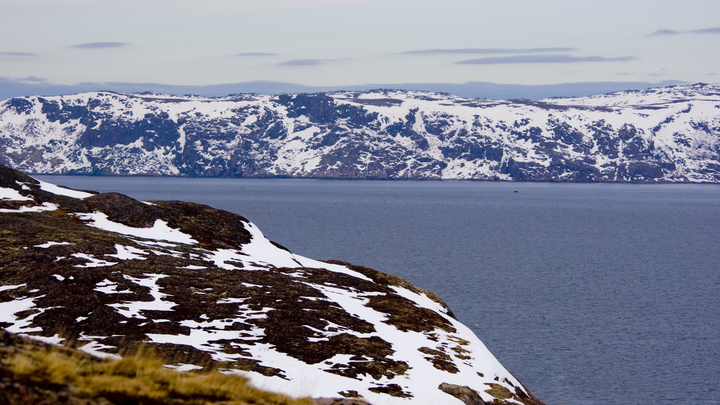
[5, 340, 315, 405]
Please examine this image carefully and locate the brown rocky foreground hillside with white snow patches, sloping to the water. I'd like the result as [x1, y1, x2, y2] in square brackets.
[0, 166, 540, 405]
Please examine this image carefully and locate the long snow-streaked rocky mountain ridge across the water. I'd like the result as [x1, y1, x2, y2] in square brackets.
[0, 84, 720, 182]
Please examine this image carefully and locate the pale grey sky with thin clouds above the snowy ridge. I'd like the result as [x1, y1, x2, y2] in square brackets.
[0, 0, 720, 97]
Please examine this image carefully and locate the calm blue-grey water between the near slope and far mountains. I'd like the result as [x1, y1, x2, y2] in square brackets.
[37, 176, 720, 405]
